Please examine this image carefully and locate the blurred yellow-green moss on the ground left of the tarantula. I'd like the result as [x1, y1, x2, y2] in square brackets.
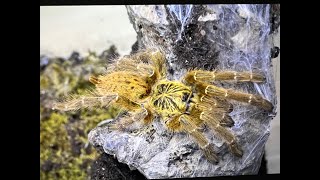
[40, 47, 117, 180]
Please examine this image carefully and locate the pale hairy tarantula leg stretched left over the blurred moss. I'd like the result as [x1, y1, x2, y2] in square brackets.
[52, 93, 118, 111]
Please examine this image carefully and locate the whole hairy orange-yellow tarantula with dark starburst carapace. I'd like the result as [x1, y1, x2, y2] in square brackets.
[54, 50, 273, 163]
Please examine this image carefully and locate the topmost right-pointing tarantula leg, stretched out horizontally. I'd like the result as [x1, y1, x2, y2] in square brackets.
[185, 70, 265, 83]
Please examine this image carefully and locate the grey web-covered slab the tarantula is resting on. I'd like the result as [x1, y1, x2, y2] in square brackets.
[88, 5, 277, 179]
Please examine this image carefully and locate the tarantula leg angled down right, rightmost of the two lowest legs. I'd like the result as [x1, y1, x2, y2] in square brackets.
[200, 112, 243, 157]
